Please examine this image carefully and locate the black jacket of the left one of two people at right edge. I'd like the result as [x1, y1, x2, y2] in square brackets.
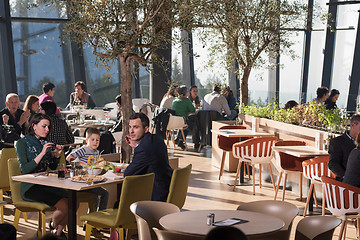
[329, 133, 356, 179]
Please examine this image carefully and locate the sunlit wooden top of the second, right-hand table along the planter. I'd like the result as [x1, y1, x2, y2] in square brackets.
[273, 146, 329, 157]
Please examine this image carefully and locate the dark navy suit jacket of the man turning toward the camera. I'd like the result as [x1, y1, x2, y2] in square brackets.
[124, 133, 172, 202]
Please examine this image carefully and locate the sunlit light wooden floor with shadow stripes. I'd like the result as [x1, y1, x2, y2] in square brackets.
[5, 143, 356, 239]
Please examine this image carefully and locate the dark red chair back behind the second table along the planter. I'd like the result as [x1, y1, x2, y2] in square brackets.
[274, 140, 308, 172]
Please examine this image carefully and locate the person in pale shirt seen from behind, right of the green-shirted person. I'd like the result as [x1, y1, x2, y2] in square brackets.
[203, 83, 237, 120]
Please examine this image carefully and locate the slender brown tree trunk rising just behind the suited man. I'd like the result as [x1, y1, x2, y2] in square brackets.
[119, 55, 132, 162]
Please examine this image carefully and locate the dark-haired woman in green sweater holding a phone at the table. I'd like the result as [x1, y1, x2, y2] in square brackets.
[16, 113, 68, 236]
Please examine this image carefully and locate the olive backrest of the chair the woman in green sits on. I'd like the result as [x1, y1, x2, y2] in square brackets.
[8, 158, 23, 206]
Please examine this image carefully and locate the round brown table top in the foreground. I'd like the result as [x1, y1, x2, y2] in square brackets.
[160, 210, 285, 236]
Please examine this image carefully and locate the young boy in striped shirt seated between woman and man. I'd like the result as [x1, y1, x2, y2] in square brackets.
[66, 128, 109, 210]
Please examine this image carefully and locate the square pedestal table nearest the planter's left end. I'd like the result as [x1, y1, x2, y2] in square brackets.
[211, 129, 274, 186]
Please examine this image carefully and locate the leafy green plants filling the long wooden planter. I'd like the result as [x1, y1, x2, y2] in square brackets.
[240, 102, 347, 132]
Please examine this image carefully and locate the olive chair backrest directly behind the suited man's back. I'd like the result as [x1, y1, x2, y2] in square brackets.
[166, 164, 192, 209]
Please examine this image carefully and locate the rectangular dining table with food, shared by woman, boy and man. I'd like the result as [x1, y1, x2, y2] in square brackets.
[12, 173, 123, 240]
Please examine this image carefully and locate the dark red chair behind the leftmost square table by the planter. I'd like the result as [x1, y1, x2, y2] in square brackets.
[218, 125, 248, 180]
